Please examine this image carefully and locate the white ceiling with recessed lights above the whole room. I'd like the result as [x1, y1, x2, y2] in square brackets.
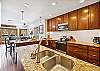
[2, 0, 99, 24]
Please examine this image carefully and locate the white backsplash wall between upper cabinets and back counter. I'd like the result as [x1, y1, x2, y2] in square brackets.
[50, 30, 100, 43]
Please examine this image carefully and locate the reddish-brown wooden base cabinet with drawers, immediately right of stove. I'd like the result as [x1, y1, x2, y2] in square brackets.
[67, 44, 88, 61]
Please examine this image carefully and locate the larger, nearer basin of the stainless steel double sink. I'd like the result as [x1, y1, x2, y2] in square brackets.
[42, 55, 74, 71]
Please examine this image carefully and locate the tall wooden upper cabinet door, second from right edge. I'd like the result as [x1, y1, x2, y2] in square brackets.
[78, 7, 89, 30]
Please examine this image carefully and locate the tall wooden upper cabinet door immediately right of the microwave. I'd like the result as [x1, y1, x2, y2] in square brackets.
[68, 10, 77, 30]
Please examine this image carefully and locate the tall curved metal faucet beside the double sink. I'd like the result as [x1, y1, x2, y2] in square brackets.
[31, 37, 48, 63]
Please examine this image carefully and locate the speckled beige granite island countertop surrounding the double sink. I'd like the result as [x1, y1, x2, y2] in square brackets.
[16, 44, 100, 71]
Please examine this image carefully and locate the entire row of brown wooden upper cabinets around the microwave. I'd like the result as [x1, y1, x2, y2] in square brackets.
[47, 2, 100, 32]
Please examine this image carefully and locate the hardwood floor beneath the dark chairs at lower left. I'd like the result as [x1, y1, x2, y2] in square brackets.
[0, 45, 24, 71]
